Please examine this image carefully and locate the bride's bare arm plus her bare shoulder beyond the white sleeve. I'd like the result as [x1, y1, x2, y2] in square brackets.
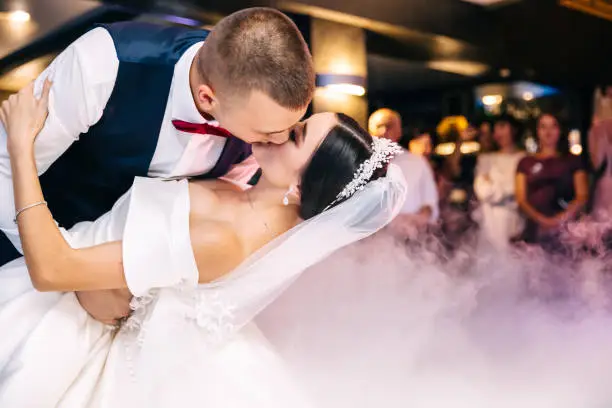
[0, 82, 244, 292]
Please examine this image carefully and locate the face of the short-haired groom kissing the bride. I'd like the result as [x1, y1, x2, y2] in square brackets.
[214, 91, 306, 144]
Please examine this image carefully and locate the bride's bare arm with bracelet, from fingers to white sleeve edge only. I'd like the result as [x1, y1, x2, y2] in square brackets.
[0, 82, 127, 291]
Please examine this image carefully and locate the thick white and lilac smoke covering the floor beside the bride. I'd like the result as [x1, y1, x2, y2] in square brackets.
[260, 226, 612, 408]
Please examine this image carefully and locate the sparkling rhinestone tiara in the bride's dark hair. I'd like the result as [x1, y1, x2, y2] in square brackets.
[327, 137, 404, 208]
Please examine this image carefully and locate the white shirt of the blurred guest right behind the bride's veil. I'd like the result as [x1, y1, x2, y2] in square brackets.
[393, 151, 439, 222]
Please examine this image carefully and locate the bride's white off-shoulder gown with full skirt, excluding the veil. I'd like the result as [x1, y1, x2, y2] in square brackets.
[0, 179, 307, 408]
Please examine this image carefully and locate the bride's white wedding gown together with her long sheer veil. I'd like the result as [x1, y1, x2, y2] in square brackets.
[0, 166, 406, 408]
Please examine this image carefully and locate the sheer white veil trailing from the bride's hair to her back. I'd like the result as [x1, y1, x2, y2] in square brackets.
[202, 165, 406, 329]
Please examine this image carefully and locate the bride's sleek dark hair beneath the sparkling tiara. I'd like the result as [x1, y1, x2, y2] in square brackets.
[300, 113, 386, 220]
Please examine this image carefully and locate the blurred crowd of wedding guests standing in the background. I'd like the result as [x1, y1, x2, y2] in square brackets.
[368, 86, 612, 253]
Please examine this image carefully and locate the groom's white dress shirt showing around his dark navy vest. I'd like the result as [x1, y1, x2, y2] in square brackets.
[0, 28, 257, 250]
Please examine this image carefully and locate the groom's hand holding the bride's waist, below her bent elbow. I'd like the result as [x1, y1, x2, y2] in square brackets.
[76, 289, 132, 325]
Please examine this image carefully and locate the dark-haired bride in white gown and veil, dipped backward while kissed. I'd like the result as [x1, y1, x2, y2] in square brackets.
[0, 79, 405, 408]
